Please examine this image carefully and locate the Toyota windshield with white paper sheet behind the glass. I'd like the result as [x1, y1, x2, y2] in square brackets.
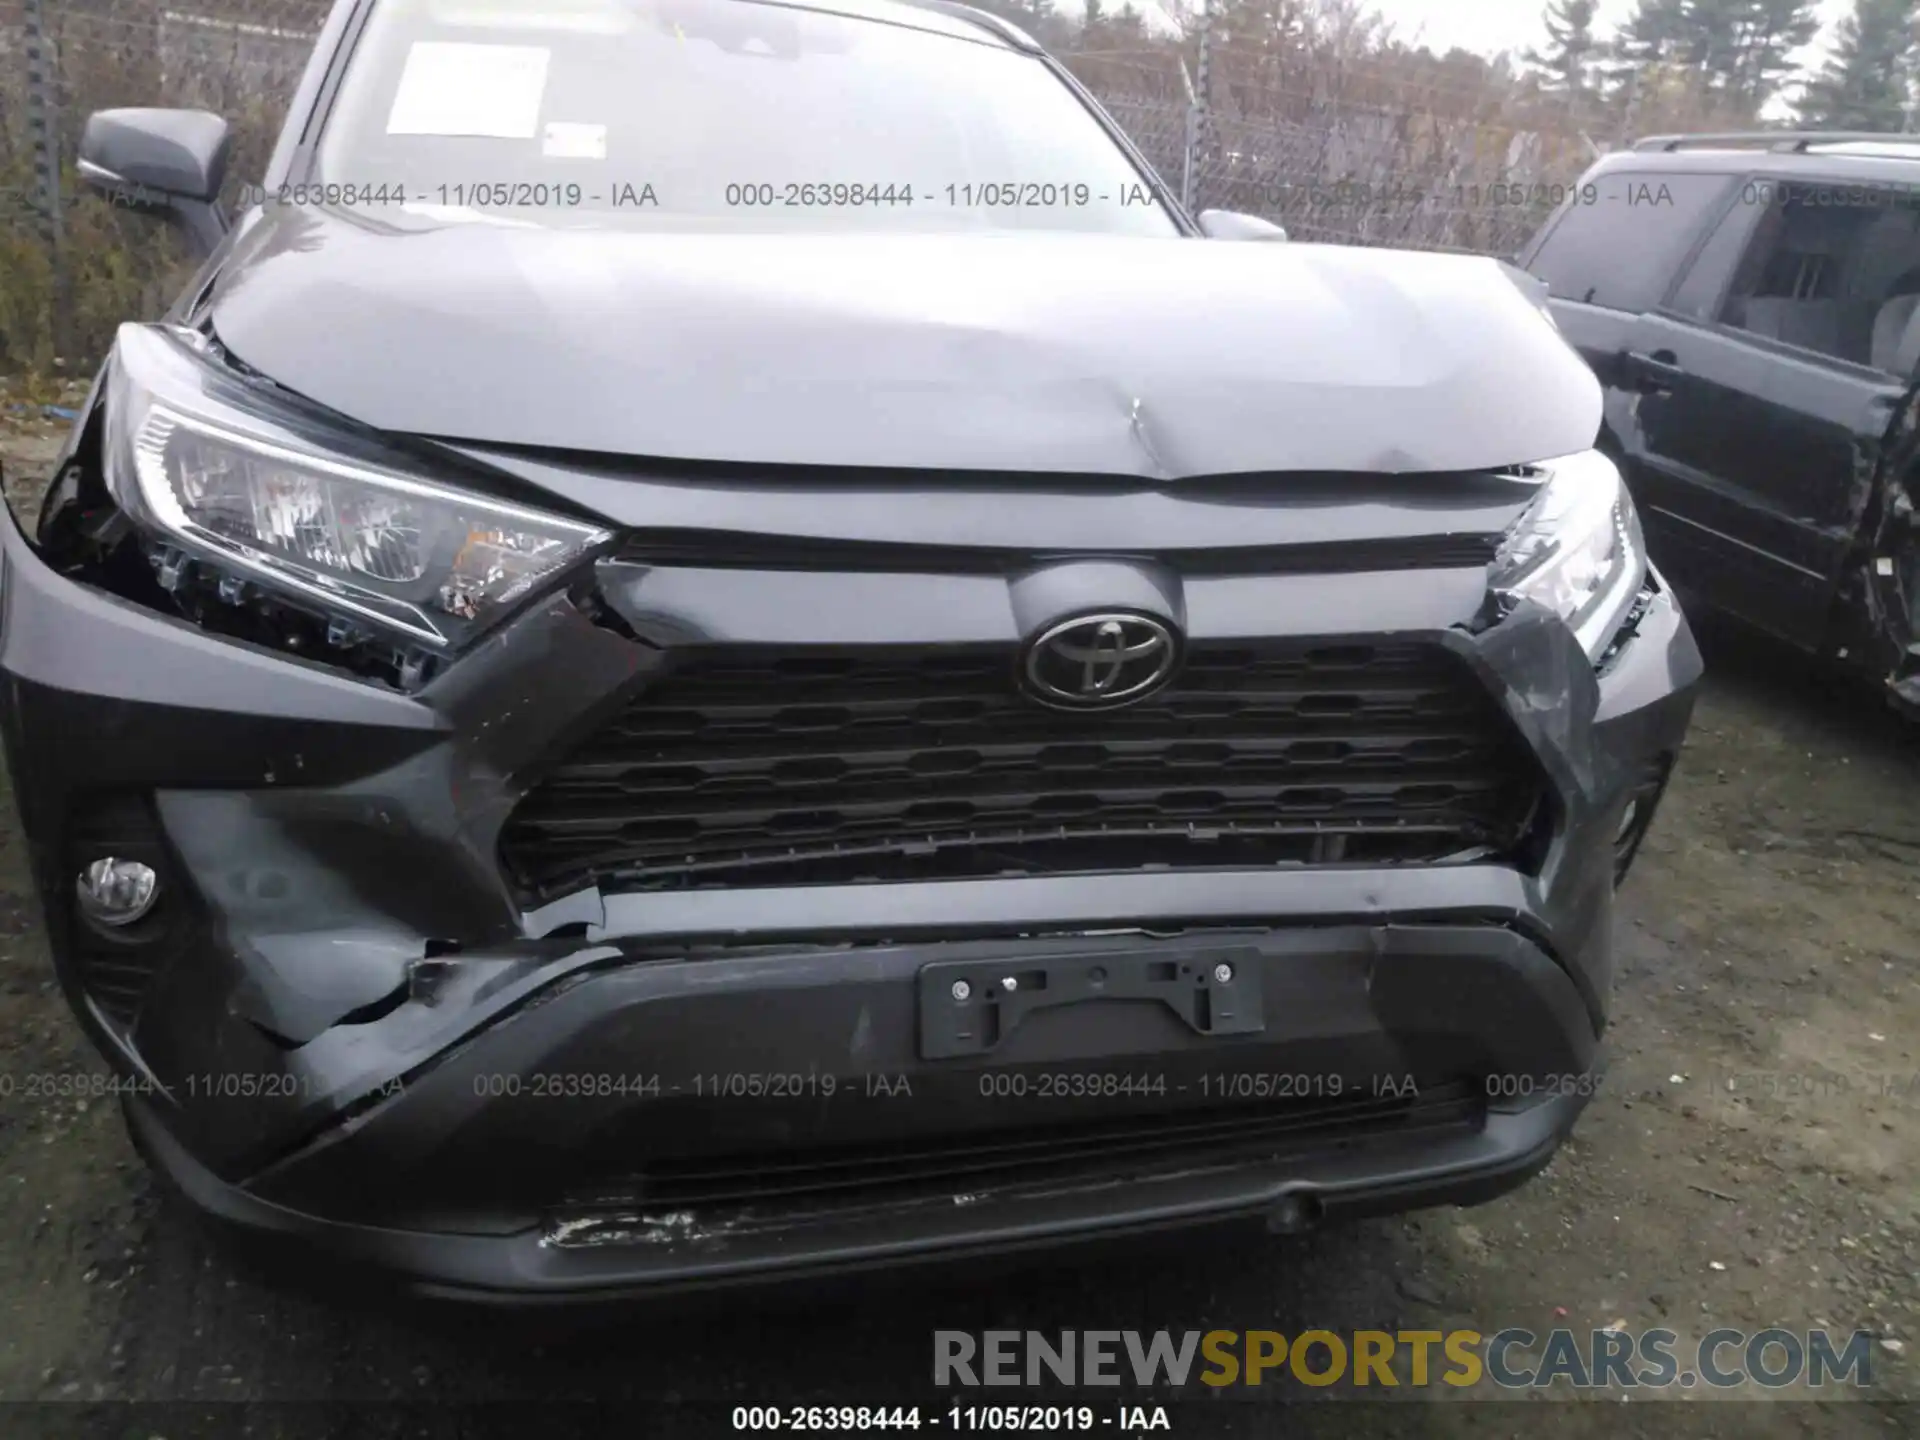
[311, 0, 1179, 236]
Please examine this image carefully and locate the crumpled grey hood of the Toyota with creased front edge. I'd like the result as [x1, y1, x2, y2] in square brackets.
[213, 211, 1601, 480]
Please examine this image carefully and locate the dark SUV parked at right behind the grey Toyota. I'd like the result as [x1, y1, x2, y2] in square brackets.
[1519, 131, 1920, 712]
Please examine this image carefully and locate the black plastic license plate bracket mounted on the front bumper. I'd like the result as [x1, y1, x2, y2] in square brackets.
[920, 947, 1267, 1060]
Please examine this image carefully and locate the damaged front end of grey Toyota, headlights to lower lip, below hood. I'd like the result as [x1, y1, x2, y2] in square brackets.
[0, 312, 1699, 1298]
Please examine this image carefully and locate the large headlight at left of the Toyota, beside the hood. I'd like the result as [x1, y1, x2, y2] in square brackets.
[106, 324, 607, 651]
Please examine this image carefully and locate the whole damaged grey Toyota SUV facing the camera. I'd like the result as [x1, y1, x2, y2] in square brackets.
[0, 0, 1699, 1300]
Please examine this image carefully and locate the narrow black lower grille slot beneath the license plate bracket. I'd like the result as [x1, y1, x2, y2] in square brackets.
[561, 1081, 1484, 1236]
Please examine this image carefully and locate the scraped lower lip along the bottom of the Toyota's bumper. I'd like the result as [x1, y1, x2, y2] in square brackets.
[129, 1094, 1584, 1308]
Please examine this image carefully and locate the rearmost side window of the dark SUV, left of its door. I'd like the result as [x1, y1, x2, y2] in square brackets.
[1526, 171, 1734, 311]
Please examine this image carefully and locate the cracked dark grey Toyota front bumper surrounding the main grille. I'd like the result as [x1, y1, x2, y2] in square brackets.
[0, 487, 1699, 1298]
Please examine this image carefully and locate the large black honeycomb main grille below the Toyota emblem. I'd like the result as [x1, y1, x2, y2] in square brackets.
[503, 643, 1538, 897]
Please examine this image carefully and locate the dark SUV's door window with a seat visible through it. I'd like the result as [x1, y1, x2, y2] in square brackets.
[1716, 180, 1920, 374]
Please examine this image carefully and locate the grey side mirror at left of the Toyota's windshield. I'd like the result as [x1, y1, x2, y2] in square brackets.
[79, 109, 232, 253]
